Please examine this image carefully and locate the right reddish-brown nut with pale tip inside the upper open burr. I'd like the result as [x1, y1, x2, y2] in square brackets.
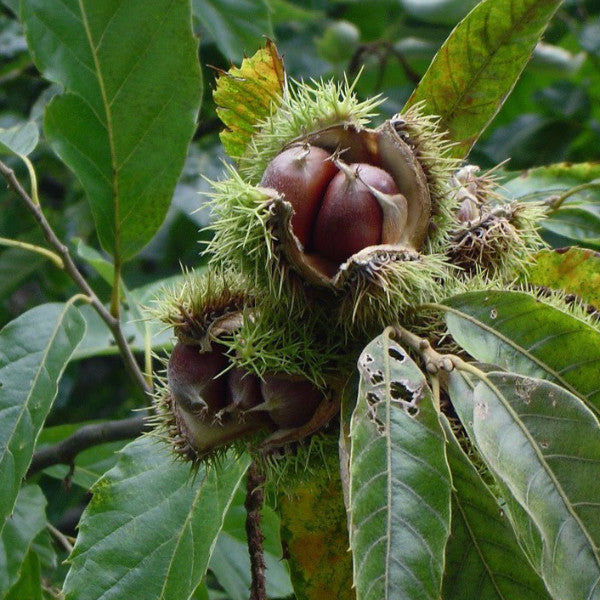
[312, 163, 398, 264]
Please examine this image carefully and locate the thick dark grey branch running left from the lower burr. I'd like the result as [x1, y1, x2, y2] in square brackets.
[27, 415, 150, 477]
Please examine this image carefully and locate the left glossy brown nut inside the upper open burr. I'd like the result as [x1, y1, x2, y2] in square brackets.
[260, 144, 337, 248]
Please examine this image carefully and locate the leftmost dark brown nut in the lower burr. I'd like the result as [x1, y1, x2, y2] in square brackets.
[167, 342, 227, 413]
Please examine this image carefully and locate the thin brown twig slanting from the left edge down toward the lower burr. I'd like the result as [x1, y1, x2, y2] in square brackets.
[0, 161, 152, 394]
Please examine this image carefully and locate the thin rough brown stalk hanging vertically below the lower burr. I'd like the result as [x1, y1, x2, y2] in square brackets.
[244, 461, 267, 600]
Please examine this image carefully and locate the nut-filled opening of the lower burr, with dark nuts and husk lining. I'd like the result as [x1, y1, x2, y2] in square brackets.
[167, 342, 338, 460]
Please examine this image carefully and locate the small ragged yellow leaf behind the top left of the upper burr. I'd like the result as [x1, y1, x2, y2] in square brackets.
[213, 40, 285, 158]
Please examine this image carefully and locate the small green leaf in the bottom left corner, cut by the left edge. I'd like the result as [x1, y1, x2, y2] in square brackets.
[0, 485, 46, 598]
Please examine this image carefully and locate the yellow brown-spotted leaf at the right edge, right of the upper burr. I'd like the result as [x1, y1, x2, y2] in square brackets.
[527, 247, 600, 308]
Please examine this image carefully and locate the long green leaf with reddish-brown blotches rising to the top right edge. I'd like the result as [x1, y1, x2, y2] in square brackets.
[405, 0, 561, 158]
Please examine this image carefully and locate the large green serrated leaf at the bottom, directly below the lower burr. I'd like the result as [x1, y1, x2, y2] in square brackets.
[65, 437, 248, 600]
